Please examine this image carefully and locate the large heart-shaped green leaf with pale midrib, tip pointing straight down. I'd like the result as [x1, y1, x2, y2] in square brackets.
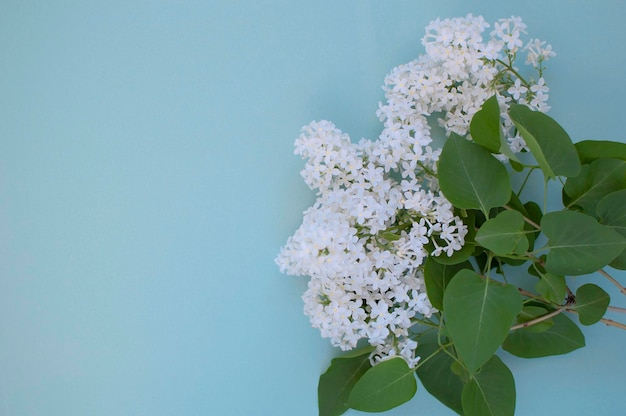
[443, 270, 522, 374]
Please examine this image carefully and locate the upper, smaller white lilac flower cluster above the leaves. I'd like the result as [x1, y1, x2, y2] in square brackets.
[378, 14, 555, 152]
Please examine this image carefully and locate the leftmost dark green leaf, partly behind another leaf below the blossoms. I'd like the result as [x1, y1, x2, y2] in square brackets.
[317, 347, 372, 416]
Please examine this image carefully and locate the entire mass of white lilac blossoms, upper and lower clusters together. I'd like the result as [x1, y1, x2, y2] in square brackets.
[276, 15, 554, 366]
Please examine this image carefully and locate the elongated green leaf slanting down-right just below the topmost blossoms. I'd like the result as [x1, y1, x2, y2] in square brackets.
[509, 104, 580, 179]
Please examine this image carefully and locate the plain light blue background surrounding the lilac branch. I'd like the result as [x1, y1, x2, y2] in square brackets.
[0, 0, 626, 416]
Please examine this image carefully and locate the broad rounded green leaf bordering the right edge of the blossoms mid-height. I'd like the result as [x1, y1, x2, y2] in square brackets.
[438, 134, 511, 215]
